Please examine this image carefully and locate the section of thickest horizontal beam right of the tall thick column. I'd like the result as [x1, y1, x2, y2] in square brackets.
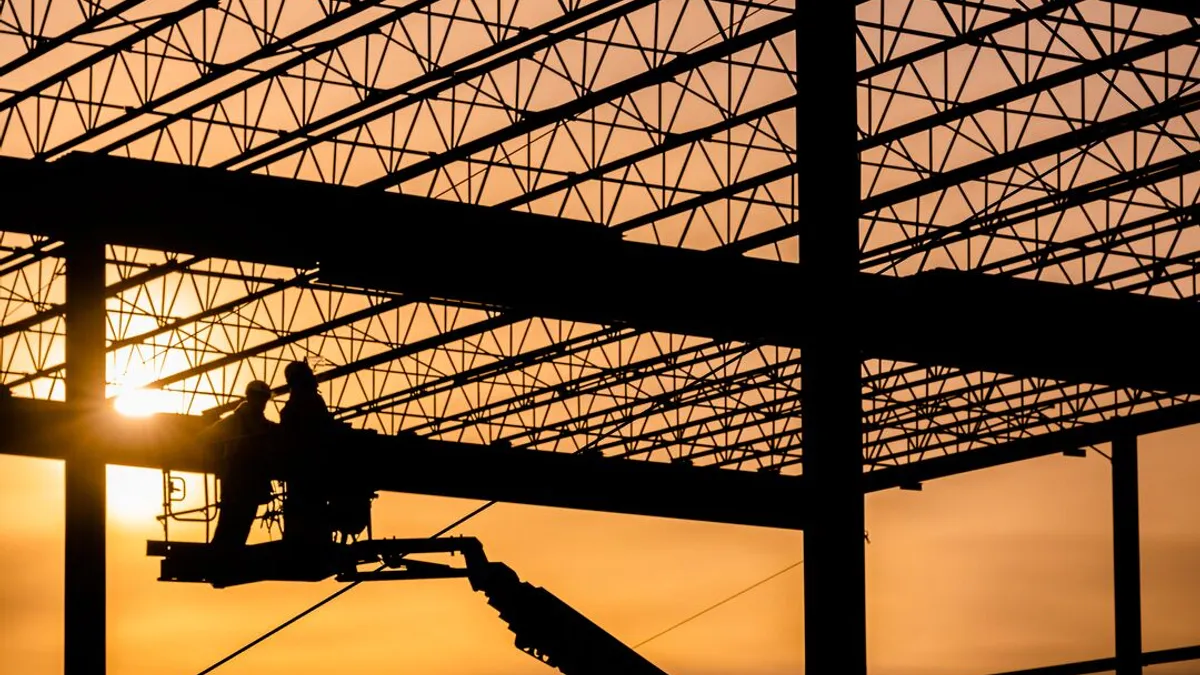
[868, 269, 1200, 394]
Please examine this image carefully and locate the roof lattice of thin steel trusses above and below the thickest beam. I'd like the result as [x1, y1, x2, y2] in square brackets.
[0, 0, 1200, 472]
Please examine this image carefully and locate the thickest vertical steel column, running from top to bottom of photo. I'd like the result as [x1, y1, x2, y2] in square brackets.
[796, 0, 866, 675]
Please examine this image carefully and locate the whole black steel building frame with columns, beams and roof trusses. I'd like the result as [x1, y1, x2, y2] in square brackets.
[0, 0, 1200, 675]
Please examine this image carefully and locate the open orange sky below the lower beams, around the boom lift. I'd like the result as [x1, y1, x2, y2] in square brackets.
[0, 422, 1200, 675]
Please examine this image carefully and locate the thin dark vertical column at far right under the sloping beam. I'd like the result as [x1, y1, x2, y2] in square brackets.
[1112, 436, 1141, 675]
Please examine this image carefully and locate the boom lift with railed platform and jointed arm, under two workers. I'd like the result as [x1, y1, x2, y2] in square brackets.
[146, 427, 666, 675]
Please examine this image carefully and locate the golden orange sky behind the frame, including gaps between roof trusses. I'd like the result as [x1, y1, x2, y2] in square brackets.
[0, 0, 1200, 675]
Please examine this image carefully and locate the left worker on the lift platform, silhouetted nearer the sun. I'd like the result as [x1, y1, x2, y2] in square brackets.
[205, 380, 276, 548]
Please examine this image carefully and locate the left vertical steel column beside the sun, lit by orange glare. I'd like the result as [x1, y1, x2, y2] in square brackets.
[65, 235, 106, 675]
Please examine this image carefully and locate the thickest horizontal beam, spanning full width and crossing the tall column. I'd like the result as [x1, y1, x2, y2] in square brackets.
[0, 155, 1200, 393]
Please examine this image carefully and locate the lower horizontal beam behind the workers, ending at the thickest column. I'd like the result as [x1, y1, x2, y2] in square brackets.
[0, 399, 805, 530]
